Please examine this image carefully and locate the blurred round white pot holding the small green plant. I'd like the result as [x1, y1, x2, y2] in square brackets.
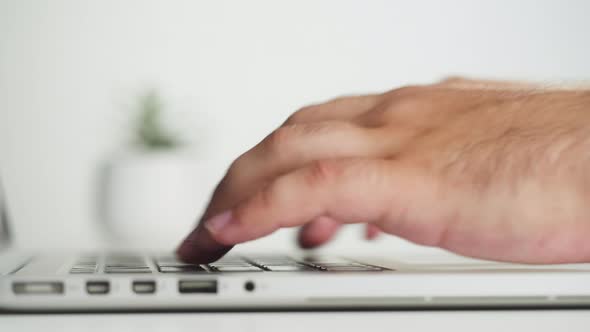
[99, 151, 209, 250]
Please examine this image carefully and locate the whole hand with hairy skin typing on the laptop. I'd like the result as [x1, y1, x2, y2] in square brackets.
[178, 79, 590, 263]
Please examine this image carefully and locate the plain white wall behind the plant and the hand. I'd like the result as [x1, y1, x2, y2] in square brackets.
[0, 0, 590, 249]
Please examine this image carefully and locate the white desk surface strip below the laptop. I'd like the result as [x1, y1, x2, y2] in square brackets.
[0, 310, 590, 332]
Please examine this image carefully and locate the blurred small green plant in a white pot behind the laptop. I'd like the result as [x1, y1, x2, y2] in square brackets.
[99, 90, 199, 249]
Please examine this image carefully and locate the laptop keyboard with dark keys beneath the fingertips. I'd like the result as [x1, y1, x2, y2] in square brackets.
[70, 253, 387, 274]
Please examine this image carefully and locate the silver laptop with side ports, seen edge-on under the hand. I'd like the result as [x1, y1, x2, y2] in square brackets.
[0, 178, 590, 312]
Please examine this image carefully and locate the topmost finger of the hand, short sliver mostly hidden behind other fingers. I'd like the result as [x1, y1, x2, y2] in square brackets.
[283, 94, 382, 126]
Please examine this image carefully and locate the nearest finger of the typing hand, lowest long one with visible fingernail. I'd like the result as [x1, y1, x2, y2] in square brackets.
[205, 159, 442, 245]
